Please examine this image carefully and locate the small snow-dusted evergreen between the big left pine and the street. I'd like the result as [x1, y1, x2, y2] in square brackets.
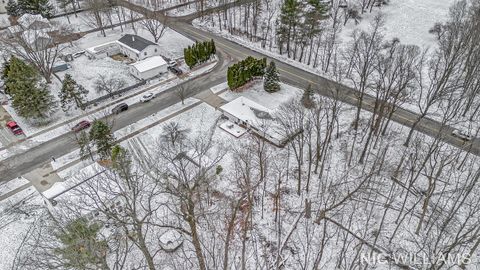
[59, 74, 88, 112]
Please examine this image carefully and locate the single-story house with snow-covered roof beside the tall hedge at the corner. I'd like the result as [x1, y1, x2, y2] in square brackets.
[219, 96, 298, 146]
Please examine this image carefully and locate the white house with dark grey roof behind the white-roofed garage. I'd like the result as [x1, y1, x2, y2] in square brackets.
[117, 34, 160, 61]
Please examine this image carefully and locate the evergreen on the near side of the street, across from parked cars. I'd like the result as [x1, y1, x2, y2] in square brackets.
[89, 120, 115, 159]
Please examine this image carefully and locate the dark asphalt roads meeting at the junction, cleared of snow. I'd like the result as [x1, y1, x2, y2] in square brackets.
[0, 1, 480, 181]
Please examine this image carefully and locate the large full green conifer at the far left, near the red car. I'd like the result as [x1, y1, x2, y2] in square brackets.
[6, 57, 55, 119]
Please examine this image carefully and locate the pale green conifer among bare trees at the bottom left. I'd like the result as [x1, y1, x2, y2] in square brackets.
[54, 218, 108, 269]
